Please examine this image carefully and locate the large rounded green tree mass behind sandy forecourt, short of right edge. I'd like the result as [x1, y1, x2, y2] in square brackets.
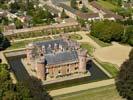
[91, 21, 124, 42]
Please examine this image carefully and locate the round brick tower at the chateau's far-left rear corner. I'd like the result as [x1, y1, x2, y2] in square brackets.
[26, 43, 34, 65]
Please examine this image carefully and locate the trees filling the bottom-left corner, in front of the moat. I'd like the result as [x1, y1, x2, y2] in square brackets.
[0, 64, 51, 100]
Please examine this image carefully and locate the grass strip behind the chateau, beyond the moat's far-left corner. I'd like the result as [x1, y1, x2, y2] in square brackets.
[7, 37, 50, 50]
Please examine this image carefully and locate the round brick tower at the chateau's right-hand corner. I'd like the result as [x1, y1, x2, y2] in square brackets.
[78, 50, 87, 73]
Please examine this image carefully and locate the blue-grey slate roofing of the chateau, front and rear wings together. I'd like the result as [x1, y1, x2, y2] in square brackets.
[33, 39, 78, 65]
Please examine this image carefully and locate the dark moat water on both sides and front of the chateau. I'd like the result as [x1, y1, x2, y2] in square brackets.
[7, 55, 109, 90]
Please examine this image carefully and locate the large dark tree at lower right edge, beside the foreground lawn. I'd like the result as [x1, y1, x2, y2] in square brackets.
[116, 50, 133, 100]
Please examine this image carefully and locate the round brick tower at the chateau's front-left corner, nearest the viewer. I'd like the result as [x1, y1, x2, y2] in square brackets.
[36, 56, 45, 80]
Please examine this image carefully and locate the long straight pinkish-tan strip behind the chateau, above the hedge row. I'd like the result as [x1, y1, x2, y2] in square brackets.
[3, 22, 79, 36]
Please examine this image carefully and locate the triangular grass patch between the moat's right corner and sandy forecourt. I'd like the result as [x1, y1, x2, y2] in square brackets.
[96, 60, 119, 77]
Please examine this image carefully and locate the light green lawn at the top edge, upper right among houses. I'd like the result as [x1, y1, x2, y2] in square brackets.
[97, 0, 119, 11]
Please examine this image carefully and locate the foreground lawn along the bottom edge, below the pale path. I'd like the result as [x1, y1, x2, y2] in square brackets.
[53, 85, 122, 100]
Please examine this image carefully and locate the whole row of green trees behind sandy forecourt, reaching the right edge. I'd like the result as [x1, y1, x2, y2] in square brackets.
[91, 21, 133, 45]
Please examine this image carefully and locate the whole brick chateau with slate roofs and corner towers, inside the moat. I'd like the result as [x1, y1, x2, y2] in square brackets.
[26, 37, 89, 80]
